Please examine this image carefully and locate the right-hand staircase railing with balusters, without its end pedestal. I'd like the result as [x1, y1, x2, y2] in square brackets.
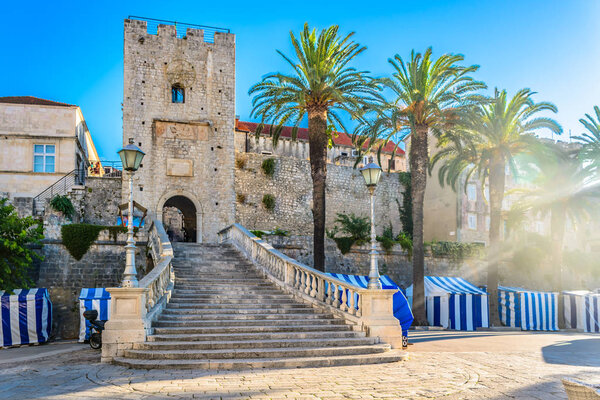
[219, 224, 369, 321]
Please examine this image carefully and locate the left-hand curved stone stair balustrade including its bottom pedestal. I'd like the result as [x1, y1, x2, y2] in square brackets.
[102, 216, 175, 362]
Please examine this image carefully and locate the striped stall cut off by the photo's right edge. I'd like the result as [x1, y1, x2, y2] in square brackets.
[563, 290, 600, 333]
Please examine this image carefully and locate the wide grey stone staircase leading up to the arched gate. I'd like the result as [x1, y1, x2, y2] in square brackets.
[114, 243, 406, 369]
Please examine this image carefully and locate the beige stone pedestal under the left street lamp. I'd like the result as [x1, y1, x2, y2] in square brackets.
[102, 288, 148, 362]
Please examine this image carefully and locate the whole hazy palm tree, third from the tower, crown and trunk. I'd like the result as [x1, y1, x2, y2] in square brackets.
[432, 89, 562, 325]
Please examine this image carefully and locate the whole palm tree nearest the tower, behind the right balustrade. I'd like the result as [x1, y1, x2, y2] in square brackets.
[249, 24, 379, 270]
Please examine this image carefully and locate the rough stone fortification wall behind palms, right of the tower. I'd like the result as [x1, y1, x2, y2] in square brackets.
[235, 153, 403, 235]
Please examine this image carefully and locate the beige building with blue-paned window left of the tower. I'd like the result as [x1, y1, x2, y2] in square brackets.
[0, 96, 98, 203]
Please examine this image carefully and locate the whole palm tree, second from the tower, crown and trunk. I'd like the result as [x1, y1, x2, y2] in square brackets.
[363, 48, 485, 325]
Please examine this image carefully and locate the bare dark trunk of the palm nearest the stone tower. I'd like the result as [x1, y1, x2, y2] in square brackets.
[308, 109, 328, 271]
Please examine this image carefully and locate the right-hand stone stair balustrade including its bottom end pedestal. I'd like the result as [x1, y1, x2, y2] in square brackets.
[219, 224, 402, 348]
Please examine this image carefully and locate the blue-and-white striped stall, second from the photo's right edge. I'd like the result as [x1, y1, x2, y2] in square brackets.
[498, 286, 558, 331]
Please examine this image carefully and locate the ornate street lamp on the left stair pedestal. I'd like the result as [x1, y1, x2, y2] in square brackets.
[118, 139, 146, 287]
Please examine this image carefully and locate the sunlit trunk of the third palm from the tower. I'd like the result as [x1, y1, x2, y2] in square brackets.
[487, 155, 506, 326]
